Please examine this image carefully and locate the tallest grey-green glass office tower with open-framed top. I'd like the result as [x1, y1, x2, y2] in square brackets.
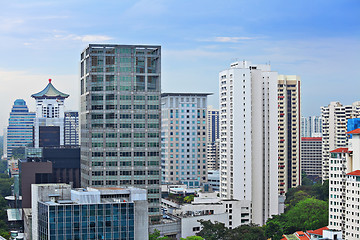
[80, 44, 161, 222]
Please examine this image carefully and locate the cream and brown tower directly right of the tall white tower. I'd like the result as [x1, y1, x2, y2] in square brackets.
[278, 75, 301, 195]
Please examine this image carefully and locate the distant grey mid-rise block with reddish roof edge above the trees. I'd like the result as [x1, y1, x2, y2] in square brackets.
[301, 137, 322, 181]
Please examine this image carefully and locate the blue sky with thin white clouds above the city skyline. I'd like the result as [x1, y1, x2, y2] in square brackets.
[0, 0, 360, 131]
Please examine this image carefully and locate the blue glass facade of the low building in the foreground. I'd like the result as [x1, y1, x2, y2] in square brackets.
[38, 202, 134, 240]
